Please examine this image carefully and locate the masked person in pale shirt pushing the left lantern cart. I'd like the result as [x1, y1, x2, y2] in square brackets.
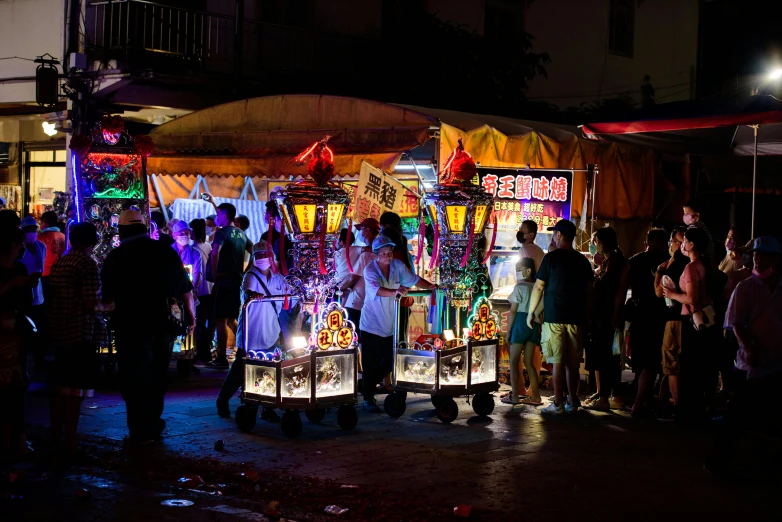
[217, 240, 293, 422]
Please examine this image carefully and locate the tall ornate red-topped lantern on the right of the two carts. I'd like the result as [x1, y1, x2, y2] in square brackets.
[424, 140, 493, 309]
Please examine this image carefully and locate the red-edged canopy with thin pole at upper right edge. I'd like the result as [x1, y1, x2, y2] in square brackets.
[582, 95, 782, 236]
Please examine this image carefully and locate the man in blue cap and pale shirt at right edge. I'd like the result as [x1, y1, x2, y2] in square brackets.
[706, 236, 782, 473]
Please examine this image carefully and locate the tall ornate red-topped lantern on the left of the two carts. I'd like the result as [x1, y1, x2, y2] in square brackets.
[274, 136, 349, 311]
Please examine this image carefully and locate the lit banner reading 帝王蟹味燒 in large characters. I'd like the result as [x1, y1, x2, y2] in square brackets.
[473, 168, 573, 233]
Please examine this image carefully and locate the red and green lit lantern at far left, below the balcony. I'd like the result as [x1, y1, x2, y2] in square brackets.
[70, 115, 155, 262]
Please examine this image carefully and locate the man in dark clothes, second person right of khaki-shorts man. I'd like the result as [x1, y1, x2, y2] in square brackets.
[626, 229, 668, 416]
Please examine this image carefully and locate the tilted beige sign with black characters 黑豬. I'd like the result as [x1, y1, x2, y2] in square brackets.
[349, 161, 418, 223]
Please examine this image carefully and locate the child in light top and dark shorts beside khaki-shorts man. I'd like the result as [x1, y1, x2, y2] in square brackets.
[502, 257, 542, 406]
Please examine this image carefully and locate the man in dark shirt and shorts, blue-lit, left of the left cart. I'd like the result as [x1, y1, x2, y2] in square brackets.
[209, 203, 252, 370]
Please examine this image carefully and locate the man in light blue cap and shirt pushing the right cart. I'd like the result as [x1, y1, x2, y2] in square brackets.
[360, 235, 432, 413]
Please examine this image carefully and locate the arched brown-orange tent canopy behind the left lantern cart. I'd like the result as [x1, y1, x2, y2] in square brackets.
[147, 95, 437, 202]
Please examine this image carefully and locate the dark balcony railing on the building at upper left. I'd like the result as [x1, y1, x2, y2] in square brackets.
[85, 0, 334, 76]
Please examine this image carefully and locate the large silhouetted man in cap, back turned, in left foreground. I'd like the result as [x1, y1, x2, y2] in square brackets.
[101, 210, 195, 444]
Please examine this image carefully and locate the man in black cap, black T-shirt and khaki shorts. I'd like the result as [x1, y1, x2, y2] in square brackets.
[527, 219, 594, 414]
